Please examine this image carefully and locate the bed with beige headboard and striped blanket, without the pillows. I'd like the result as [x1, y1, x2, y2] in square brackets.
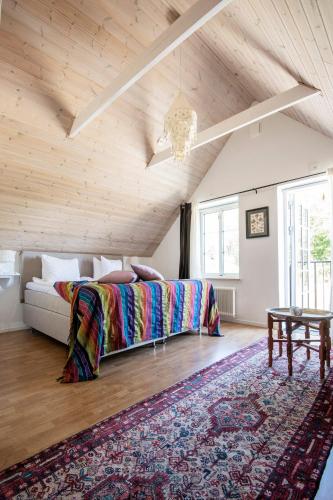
[22, 252, 221, 382]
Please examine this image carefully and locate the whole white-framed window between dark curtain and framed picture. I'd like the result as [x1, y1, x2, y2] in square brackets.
[200, 198, 239, 278]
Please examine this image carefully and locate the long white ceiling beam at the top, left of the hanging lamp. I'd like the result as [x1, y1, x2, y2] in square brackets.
[69, 0, 232, 137]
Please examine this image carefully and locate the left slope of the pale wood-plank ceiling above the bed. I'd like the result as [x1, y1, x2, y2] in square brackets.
[0, 0, 244, 255]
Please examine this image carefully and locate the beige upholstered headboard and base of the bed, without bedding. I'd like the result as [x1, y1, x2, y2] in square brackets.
[21, 251, 201, 356]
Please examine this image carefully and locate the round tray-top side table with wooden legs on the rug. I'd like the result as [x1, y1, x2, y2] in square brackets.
[266, 307, 333, 379]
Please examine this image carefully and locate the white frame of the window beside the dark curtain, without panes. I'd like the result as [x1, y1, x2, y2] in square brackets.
[199, 198, 239, 279]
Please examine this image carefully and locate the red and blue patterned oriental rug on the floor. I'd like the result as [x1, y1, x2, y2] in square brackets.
[0, 341, 333, 500]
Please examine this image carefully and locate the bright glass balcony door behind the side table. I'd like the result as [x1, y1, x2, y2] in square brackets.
[283, 179, 331, 309]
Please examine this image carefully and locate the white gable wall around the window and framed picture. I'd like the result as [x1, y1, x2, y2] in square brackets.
[153, 114, 333, 325]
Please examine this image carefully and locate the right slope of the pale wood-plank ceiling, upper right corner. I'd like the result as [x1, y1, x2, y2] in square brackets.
[197, 0, 333, 137]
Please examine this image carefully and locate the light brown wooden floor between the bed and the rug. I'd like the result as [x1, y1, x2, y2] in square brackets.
[0, 324, 266, 469]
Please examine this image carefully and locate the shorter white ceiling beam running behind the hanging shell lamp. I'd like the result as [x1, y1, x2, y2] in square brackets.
[147, 84, 321, 167]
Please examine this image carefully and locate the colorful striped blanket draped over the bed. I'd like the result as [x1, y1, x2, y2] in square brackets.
[54, 280, 221, 382]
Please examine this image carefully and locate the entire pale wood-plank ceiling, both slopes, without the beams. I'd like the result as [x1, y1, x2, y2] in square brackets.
[0, 0, 333, 255]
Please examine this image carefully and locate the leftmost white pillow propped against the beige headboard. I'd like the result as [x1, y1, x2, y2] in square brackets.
[42, 255, 80, 283]
